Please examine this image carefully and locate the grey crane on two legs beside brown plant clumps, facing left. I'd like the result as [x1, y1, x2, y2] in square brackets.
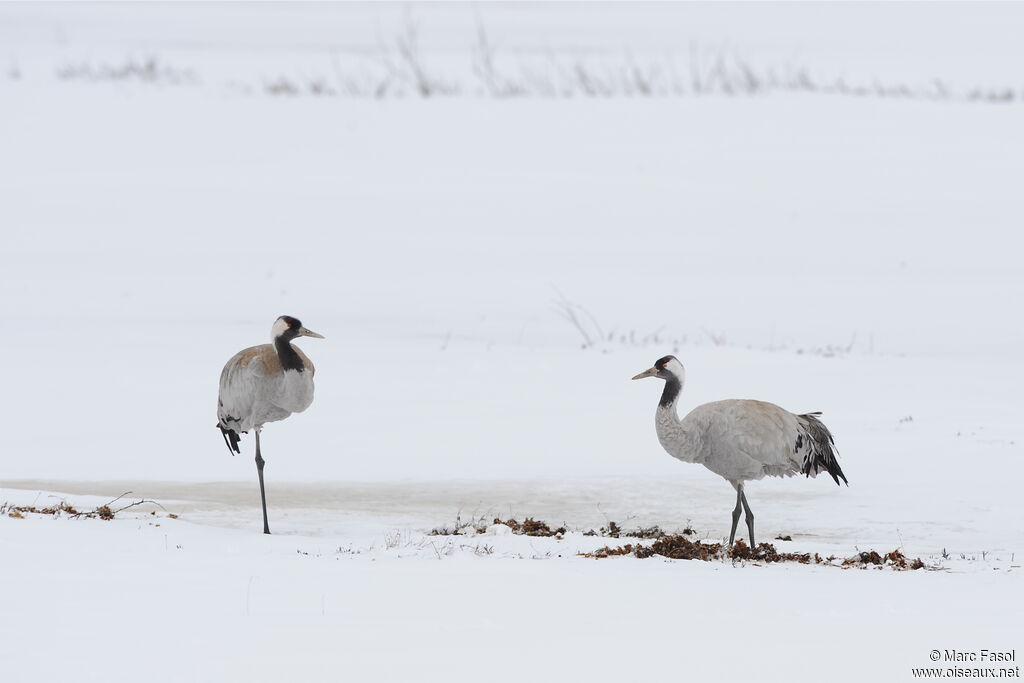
[633, 355, 849, 548]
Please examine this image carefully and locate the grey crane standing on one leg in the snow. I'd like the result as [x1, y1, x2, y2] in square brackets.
[217, 315, 324, 533]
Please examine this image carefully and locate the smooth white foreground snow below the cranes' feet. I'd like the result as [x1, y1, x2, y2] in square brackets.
[0, 487, 1021, 681]
